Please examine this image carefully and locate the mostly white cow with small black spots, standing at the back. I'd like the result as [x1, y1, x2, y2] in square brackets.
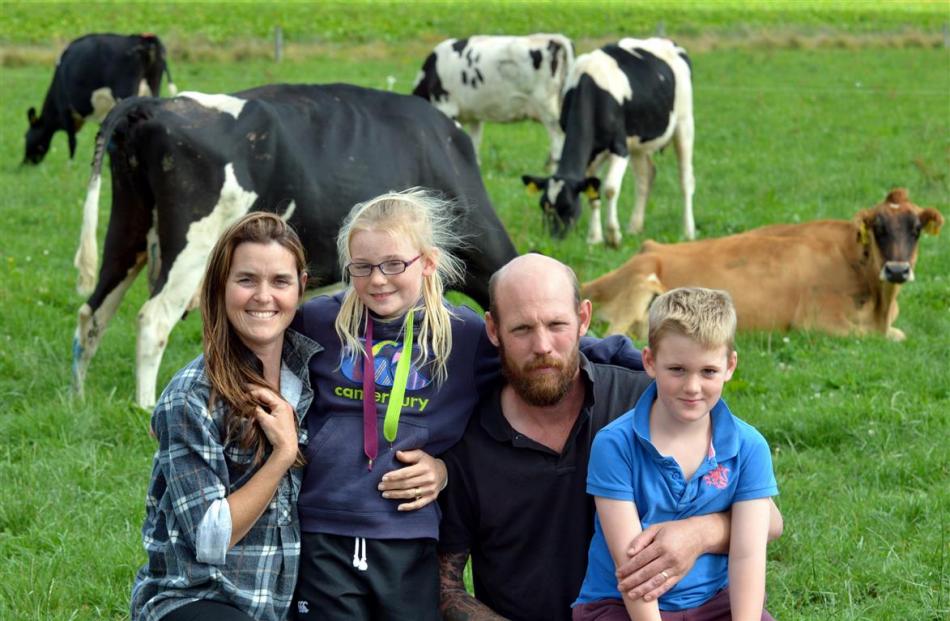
[412, 33, 574, 170]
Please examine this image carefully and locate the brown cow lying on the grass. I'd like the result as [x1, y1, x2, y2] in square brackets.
[582, 188, 943, 341]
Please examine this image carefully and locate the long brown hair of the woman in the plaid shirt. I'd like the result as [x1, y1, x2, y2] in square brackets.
[201, 211, 307, 466]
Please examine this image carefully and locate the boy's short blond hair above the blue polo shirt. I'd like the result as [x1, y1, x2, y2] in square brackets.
[647, 287, 736, 351]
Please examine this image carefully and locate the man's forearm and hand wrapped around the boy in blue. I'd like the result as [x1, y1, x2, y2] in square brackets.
[617, 498, 784, 601]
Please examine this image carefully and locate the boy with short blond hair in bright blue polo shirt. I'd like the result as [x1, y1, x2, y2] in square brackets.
[573, 288, 778, 621]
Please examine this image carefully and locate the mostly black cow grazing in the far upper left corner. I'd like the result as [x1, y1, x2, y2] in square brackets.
[23, 34, 176, 164]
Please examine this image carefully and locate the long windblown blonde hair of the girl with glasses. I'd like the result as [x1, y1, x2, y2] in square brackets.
[334, 188, 464, 383]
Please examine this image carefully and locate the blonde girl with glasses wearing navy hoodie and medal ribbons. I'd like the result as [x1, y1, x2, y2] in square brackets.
[294, 189, 498, 621]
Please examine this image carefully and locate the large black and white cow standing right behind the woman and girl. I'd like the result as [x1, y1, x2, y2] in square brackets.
[73, 84, 516, 407]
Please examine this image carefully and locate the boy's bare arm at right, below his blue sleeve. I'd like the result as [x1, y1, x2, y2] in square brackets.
[729, 498, 769, 621]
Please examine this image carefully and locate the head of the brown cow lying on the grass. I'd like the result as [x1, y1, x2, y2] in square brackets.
[855, 188, 943, 285]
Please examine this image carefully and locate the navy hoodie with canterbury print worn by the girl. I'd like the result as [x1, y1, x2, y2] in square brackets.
[293, 294, 499, 539]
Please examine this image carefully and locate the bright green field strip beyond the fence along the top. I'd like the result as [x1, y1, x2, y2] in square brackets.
[0, 0, 947, 45]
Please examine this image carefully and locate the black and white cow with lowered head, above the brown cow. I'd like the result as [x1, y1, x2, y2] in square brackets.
[521, 38, 696, 246]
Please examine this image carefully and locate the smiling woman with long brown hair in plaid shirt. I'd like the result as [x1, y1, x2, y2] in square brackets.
[131, 212, 321, 621]
